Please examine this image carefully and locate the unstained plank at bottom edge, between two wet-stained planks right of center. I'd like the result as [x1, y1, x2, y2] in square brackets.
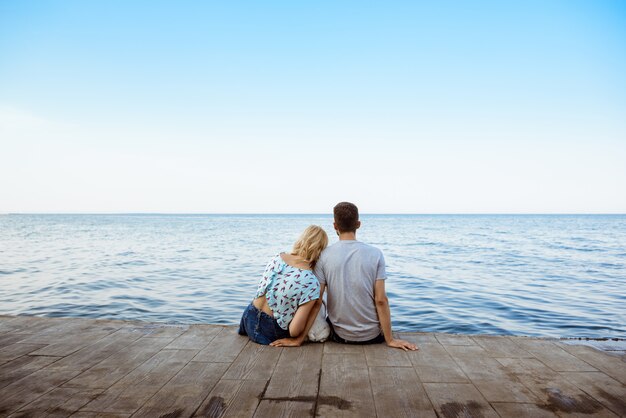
[369, 367, 437, 418]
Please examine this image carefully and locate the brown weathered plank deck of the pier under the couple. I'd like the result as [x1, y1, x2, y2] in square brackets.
[0, 316, 626, 418]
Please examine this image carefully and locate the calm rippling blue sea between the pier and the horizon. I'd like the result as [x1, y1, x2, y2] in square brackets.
[0, 215, 626, 338]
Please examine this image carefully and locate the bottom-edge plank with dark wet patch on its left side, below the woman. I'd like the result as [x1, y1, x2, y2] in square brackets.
[194, 379, 267, 418]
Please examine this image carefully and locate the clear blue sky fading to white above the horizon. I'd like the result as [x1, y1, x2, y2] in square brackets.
[0, 0, 626, 213]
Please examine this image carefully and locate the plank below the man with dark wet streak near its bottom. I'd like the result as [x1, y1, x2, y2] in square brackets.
[316, 354, 376, 417]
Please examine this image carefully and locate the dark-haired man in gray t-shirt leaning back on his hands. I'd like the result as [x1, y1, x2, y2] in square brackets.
[272, 202, 417, 351]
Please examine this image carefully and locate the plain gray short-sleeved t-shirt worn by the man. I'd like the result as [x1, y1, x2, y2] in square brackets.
[315, 240, 387, 341]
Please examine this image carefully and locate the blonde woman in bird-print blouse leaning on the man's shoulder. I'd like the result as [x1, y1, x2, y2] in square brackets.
[239, 225, 328, 345]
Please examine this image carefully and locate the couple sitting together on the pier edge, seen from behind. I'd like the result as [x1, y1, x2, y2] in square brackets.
[239, 202, 417, 350]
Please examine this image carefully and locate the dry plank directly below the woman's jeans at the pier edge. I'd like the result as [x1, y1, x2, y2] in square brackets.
[224, 343, 283, 380]
